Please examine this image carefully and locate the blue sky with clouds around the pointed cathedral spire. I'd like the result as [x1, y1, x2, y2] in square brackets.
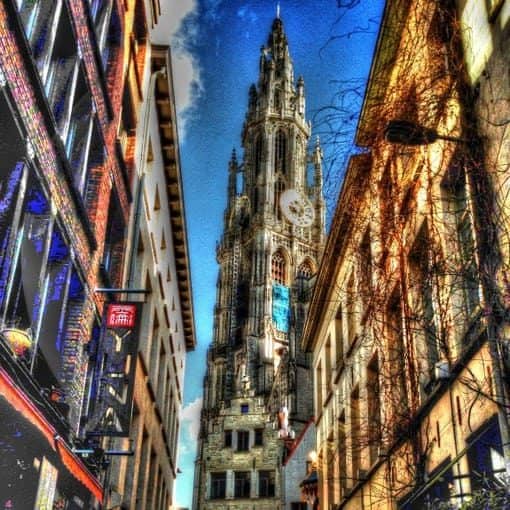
[160, 0, 382, 508]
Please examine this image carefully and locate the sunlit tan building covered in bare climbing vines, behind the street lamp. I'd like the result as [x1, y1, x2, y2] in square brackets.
[303, 0, 510, 509]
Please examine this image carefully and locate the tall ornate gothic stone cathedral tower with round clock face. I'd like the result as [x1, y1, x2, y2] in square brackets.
[193, 17, 325, 510]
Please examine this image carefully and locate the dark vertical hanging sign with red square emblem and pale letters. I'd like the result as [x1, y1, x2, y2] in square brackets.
[87, 303, 142, 437]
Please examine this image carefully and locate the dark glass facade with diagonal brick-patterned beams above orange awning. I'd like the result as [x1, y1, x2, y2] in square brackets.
[0, 0, 130, 508]
